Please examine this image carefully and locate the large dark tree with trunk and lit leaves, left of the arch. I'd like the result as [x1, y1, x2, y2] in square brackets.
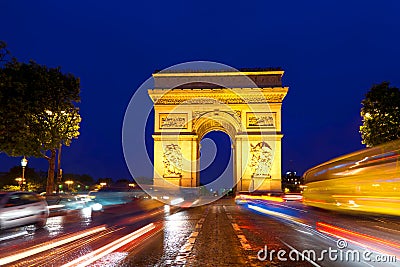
[0, 43, 81, 194]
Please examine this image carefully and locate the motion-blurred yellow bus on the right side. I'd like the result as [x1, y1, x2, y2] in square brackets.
[303, 139, 400, 216]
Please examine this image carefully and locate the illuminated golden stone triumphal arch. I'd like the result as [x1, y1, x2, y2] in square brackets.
[148, 69, 288, 191]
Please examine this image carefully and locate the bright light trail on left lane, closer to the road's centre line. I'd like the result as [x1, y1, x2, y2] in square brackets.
[61, 223, 155, 267]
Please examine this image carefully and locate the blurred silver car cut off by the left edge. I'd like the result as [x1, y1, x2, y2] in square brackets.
[0, 192, 49, 230]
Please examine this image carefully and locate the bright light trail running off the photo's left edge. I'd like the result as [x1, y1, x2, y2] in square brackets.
[0, 226, 106, 266]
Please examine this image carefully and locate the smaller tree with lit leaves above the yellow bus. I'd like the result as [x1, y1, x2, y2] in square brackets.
[360, 82, 400, 147]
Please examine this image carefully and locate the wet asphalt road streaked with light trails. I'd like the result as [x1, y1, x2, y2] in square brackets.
[0, 199, 400, 267]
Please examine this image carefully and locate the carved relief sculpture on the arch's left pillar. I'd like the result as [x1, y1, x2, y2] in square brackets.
[163, 144, 182, 177]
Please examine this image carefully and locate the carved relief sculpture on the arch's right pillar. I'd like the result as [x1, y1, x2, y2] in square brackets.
[250, 142, 272, 177]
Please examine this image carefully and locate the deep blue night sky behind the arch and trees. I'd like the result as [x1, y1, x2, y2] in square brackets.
[0, 0, 400, 182]
